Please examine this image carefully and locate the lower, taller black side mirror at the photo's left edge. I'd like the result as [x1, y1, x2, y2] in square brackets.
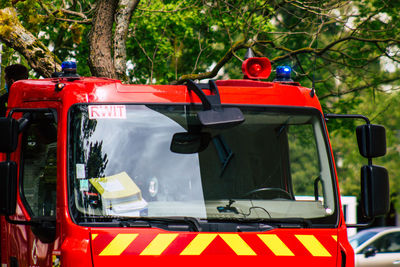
[0, 161, 18, 215]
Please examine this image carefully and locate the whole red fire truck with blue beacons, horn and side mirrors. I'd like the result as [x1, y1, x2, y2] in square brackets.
[0, 55, 389, 267]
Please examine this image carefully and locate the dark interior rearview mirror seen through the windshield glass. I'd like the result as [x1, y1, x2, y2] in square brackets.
[170, 132, 211, 154]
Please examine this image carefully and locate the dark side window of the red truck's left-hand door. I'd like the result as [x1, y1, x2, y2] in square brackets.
[21, 112, 57, 217]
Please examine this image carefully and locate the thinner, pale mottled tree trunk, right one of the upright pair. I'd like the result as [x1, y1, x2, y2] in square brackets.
[114, 0, 140, 82]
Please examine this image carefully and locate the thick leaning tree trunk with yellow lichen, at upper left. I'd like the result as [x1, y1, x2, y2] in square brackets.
[0, 7, 61, 77]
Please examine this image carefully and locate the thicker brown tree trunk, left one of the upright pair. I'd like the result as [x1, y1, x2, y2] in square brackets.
[89, 0, 118, 79]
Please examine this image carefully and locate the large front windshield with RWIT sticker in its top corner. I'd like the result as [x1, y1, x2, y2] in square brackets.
[69, 105, 337, 225]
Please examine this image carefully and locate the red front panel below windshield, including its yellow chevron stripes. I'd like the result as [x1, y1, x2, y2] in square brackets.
[91, 228, 338, 267]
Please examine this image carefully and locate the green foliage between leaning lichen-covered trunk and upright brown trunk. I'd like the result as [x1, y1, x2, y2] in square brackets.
[6, 0, 95, 76]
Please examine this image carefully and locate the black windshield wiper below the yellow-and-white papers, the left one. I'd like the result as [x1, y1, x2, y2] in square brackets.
[81, 216, 201, 232]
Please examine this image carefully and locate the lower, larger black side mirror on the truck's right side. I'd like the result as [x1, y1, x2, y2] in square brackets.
[361, 165, 390, 218]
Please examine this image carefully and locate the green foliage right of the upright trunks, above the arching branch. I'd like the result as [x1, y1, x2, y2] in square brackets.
[127, 0, 271, 84]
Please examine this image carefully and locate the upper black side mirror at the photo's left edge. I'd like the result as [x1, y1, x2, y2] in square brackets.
[0, 118, 19, 153]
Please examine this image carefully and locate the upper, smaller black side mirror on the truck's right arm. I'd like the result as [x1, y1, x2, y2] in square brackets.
[356, 124, 386, 158]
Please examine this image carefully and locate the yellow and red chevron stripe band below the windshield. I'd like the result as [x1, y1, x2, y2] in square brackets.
[92, 232, 337, 257]
